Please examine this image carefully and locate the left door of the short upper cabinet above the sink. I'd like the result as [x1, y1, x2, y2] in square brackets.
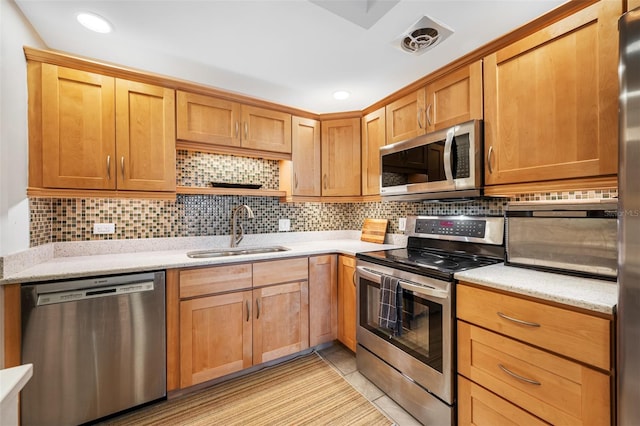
[176, 91, 240, 146]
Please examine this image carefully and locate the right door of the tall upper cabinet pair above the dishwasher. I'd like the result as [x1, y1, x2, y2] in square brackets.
[116, 79, 176, 191]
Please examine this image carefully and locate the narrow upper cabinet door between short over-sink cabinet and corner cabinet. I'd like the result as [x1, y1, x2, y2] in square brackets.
[291, 117, 322, 196]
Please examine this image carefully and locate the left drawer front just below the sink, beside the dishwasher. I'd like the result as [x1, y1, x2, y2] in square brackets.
[180, 263, 251, 299]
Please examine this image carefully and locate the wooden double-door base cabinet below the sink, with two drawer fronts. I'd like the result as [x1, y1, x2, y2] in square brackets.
[176, 258, 309, 388]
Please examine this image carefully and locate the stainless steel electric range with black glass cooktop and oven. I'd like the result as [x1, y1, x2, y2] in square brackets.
[356, 216, 504, 425]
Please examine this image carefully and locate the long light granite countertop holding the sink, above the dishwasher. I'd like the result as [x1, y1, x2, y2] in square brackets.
[0, 231, 404, 284]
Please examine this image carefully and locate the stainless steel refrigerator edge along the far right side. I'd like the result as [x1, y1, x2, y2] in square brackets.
[617, 8, 640, 426]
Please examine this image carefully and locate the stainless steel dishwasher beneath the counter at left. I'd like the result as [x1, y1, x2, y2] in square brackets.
[21, 272, 166, 426]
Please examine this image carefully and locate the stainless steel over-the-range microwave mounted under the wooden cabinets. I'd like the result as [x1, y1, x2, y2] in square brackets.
[380, 120, 484, 200]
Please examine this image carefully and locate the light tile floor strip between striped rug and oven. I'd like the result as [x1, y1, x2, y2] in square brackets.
[318, 343, 420, 426]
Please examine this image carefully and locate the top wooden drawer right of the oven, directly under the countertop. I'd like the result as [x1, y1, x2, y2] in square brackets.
[457, 285, 611, 370]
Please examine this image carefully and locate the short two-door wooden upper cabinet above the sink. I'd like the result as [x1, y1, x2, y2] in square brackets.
[176, 91, 291, 154]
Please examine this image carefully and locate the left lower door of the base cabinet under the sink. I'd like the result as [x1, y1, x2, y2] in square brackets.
[180, 291, 252, 388]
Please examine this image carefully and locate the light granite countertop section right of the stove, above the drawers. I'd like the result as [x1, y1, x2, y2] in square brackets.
[455, 263, 618, 314]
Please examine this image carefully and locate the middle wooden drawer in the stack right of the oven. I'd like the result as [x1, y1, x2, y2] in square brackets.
[458, 321, 611, 425]
